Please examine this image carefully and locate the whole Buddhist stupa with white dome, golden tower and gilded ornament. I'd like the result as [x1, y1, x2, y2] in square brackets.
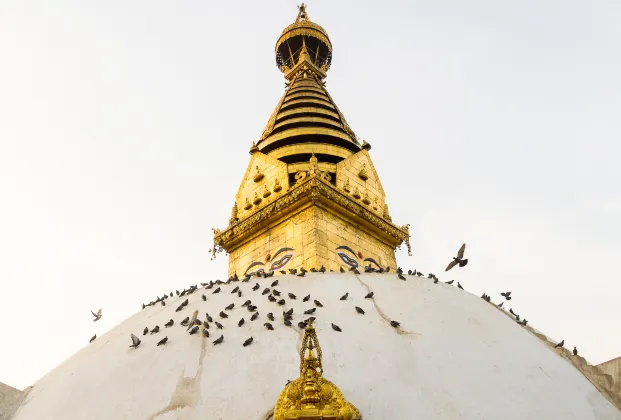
[4, 5, 621, 420]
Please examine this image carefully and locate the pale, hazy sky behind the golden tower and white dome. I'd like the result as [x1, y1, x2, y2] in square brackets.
[0, 0, 621, 388]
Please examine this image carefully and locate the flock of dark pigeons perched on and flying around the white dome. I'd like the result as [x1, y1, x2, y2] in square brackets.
[90, 244, 578, 356]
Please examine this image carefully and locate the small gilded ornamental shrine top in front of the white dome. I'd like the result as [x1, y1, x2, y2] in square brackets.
[274, 323, 362, 420]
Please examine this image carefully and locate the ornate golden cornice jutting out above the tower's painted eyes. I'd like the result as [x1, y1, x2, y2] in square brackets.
[214, 172, 409, 251]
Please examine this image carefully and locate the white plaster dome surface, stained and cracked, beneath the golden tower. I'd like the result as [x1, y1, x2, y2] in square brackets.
[8, 273, 621, 420]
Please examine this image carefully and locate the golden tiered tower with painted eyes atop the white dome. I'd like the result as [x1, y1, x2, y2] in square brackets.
[214, 4, 409, 275]
